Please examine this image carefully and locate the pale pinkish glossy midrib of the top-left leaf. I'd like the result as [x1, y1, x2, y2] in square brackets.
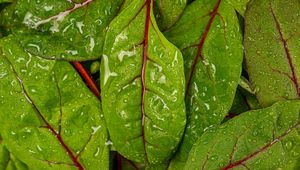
[34, 0, 94, 28]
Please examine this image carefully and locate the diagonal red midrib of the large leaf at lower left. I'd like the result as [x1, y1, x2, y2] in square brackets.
[6, 59, 84, 170]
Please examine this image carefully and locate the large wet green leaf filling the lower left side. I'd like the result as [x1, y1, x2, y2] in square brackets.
[0, 36, 108, 170]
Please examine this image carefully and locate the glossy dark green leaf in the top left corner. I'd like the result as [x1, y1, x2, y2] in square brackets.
[0, 0, 123, 60]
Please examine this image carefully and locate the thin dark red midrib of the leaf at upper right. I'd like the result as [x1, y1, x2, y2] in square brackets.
[270, 4, 300, 97]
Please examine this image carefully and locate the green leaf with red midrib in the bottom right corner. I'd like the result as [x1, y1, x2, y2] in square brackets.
[185, 101, 300, 170]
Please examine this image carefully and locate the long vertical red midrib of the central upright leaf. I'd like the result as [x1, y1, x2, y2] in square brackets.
[141, 0, 152, 161]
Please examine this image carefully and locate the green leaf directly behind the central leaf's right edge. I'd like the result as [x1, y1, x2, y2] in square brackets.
[165, 0, 243, 169]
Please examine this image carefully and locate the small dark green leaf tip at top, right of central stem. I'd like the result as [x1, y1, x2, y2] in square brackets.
[154, 0, 187, 30]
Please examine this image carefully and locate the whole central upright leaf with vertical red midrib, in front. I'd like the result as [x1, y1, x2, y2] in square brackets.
[100, 0, 186, 164]
